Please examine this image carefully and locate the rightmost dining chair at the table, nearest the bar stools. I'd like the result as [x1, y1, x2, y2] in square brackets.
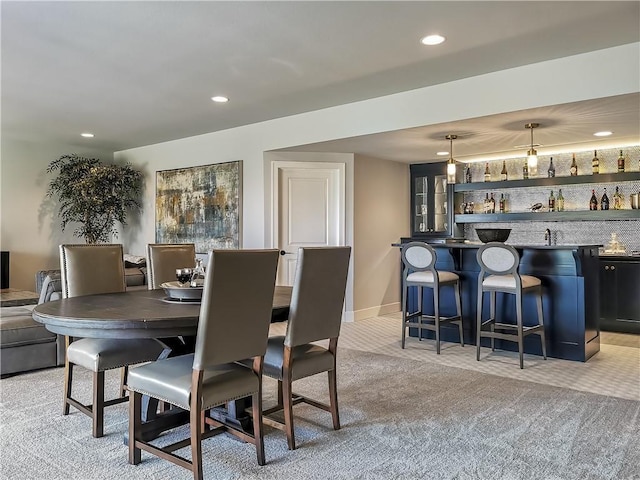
[255, 246, 351, 450]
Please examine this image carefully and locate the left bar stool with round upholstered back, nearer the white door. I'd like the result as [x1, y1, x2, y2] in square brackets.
[402, 242, 464, 354]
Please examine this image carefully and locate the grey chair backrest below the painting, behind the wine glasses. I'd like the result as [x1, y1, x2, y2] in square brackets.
[147, 243, 196, 290]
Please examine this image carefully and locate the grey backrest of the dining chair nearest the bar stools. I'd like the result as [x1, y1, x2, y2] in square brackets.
[284, 246, 351, 347]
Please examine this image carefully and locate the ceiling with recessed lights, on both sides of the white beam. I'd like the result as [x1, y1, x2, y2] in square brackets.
[0, 1, 640, 162]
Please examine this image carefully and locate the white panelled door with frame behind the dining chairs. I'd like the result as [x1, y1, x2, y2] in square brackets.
[271, 162, 345, 285]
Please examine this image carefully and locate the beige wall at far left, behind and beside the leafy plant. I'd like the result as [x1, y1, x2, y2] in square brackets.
[0, 137, 113, 291]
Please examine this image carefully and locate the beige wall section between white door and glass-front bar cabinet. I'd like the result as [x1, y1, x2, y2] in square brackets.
[353, 155, 410, 320]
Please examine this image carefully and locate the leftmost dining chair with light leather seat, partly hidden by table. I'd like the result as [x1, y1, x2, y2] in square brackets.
[60, 244, 164, 437]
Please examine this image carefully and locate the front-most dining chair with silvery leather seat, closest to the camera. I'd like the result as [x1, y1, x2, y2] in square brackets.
[127, 249, 279, 479]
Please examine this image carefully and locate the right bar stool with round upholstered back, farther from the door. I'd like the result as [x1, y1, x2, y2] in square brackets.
[476, 242, 547, 368]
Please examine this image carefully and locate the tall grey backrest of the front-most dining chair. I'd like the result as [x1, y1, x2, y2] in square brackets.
[193, 249, 278, 370]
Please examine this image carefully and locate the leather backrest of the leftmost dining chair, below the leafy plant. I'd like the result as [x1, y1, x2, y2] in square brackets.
[60, 244, 126, 298]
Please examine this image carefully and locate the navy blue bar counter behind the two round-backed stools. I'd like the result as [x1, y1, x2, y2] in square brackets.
[393, 242, 601, 362]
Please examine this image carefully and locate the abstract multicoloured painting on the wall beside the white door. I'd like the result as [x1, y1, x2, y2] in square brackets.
[156, 161, 242, 253]
